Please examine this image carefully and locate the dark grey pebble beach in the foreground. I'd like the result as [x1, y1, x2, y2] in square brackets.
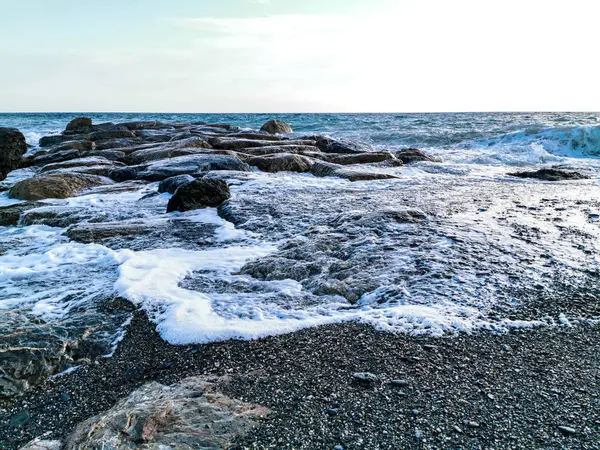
[0, 312, 600, 450]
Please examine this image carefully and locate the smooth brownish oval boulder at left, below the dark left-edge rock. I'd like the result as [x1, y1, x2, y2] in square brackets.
[8, 173, 113, 200]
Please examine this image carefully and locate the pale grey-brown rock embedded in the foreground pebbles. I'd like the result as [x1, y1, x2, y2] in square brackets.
[65, 377, 269, 450]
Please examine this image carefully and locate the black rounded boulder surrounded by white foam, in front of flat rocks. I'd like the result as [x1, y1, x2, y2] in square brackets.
[167, 179, 231, 213]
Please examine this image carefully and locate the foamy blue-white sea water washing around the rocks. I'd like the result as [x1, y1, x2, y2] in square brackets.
[0, 113, 600, 356]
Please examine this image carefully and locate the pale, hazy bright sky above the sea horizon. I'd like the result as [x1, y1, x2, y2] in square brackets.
[0, 0, 600, 112]
